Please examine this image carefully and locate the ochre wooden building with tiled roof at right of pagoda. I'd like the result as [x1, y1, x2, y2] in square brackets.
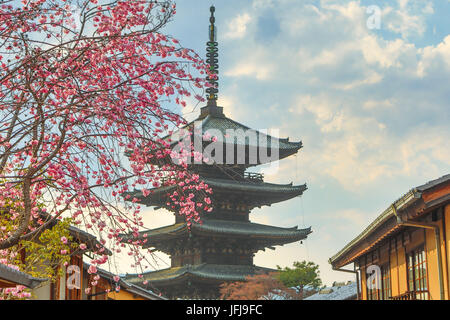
[330, 174, 450, 300]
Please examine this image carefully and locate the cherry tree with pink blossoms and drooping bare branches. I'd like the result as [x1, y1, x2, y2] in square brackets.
[0, 0, 211, 296]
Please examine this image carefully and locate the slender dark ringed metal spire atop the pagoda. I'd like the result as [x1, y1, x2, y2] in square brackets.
[206, 6, 219, 106]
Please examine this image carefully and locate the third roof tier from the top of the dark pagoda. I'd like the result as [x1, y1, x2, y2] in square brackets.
[118, 219, 312, 248]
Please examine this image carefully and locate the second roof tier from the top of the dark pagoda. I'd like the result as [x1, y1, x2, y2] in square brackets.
[126, 177, 307, 206]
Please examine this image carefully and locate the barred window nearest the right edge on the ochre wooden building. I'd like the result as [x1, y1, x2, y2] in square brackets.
[406, 245, 429, 300]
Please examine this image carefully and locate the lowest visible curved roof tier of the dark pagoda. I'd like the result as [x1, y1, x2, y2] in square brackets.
[125, 263, 276, 286]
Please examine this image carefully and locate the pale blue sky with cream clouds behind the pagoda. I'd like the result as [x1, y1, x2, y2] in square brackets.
[109, 0, 450, 285]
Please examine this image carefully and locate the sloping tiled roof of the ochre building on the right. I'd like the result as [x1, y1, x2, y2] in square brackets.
[329, 174, 450, 267]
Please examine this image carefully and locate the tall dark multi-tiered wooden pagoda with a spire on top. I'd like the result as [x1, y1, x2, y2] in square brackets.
[122, 6, 311, 299]
